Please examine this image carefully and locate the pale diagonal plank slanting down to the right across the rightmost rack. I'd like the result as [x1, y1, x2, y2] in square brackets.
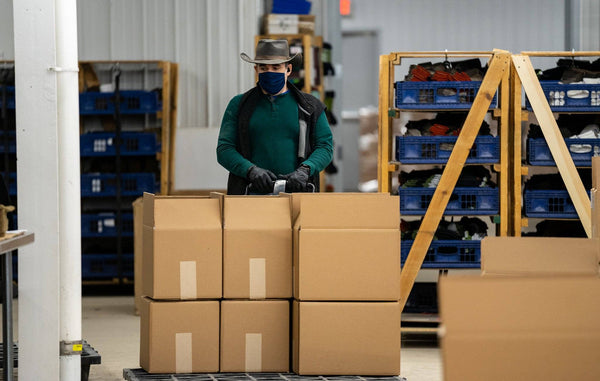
[512, 55, 592, 237]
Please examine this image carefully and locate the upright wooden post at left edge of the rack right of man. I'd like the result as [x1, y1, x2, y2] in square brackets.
[377, 55, 393, 192]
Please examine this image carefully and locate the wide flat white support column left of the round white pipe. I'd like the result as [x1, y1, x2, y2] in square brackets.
[13, 0, 61, 381]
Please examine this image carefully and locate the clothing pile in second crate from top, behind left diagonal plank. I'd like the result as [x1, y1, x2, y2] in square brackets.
[404, 112, 490, 137]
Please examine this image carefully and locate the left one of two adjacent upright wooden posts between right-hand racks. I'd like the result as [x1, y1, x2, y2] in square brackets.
[498, 60, 512, 237]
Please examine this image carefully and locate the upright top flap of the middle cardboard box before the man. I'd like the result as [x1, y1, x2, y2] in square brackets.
[223, 196, 292, 230]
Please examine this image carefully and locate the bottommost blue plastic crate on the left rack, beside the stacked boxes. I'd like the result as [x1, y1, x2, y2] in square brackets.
[81, 253, 133, 280]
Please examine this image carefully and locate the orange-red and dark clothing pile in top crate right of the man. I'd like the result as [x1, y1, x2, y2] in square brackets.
[404, 58, 485, 82]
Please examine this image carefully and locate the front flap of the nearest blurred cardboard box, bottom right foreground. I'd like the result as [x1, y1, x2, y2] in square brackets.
[439, 276, 600, 336]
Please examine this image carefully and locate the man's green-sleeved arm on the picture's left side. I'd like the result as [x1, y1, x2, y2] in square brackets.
[217, 95, 253, 178]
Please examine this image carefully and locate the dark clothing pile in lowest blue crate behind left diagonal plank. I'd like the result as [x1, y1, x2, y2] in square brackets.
[400, 217, 488, 241]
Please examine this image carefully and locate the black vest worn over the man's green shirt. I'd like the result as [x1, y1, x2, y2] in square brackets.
[227, 82, 325, 195]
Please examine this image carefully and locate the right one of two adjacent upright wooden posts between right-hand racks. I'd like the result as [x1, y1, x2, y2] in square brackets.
[509, 61, 529, 237]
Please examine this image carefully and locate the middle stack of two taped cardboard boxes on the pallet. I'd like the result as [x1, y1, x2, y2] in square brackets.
[220, 196, 292, 372]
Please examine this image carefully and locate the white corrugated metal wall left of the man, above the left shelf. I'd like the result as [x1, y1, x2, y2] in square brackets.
[78, 0, 261, 128]
